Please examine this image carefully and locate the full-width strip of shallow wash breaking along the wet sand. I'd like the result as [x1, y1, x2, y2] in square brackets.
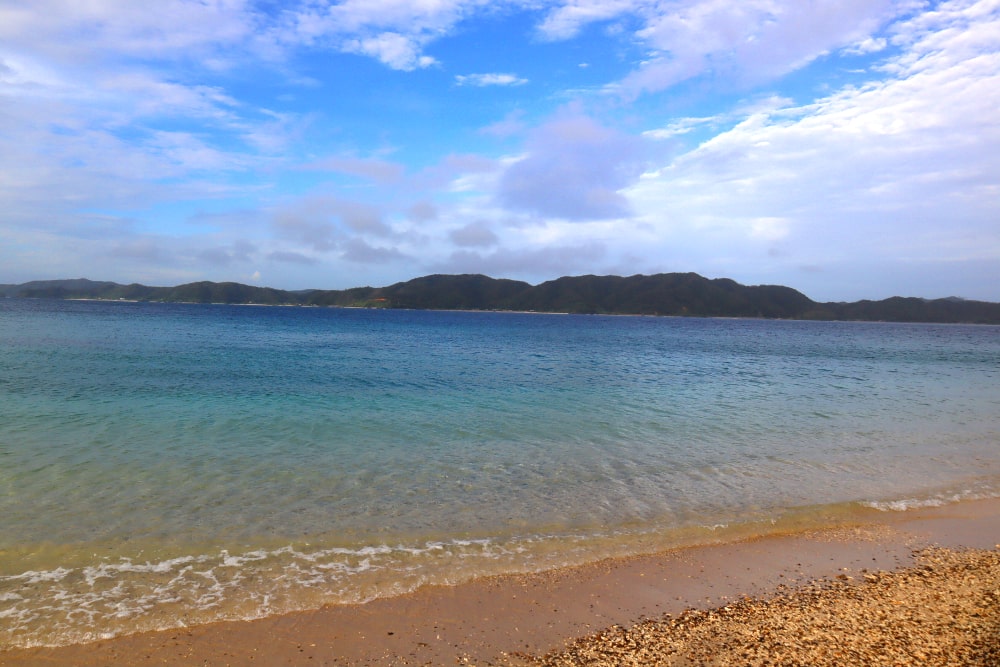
[9, 489, 1000, 648]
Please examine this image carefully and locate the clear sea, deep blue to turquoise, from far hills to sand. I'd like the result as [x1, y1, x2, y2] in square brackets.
[0, 299, 1000, 646]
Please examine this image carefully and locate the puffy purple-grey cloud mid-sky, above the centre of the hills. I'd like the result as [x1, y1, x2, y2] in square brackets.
[499, 114, 644, 220]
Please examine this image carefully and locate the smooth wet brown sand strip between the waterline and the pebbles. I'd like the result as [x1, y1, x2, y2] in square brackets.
[0, 499, 1000, 667]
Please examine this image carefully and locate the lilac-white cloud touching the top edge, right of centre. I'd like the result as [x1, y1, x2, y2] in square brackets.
[538, 0, 919, 97]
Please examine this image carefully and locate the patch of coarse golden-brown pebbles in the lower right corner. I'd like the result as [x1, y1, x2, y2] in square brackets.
[509, 545, 1000, 667]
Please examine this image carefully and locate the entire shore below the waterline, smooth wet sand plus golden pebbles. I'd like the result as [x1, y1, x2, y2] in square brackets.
[0, 500, 1000, 667]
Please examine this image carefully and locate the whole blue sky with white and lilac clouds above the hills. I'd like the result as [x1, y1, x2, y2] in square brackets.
[0, 0, 1000, 301]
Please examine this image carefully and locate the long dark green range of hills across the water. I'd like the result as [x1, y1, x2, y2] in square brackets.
[0, 273, 1000, 324]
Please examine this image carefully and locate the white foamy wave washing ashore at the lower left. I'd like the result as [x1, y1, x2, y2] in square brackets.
[0, 538, 556, 647]
